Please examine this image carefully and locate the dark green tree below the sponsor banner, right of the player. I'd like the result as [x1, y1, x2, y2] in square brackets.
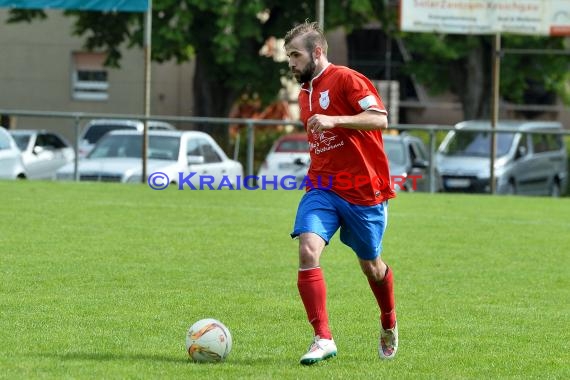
[402, 33, 570, 119]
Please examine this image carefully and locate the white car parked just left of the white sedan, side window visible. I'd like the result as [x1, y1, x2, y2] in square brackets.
[10, 129, 75, 179]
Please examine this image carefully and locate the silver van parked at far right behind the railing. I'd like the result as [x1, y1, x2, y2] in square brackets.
[437, 120, 568, 196]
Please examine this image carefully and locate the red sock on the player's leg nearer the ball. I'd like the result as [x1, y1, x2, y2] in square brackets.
[297, 268, 332, 339]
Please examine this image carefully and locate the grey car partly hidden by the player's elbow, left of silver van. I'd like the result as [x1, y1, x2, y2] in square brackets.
[382, 133, 439, 191]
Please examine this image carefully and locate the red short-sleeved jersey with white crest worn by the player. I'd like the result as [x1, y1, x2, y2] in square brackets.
[299, 64, 396, 206]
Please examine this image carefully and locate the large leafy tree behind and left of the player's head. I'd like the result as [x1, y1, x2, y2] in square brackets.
[5, 0, 382, 147]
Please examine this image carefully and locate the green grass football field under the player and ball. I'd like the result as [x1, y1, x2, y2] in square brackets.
[0, 182, 570, 379]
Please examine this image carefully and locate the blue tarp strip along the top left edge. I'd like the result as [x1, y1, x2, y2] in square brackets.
[0, 0, 148, 12]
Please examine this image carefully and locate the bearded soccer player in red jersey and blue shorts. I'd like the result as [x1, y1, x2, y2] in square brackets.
[285, 21, 398, 365]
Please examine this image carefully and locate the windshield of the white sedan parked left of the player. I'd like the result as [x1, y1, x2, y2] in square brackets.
[88, 135, 180, 161]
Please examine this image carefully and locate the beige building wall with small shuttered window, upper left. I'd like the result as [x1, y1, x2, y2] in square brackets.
[0, 9, 194, 144]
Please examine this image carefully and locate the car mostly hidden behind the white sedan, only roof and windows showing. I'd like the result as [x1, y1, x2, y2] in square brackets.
[79, 119, 176, 157]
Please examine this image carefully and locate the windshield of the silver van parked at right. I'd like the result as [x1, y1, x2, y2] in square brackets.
[441, 131, 515, 157]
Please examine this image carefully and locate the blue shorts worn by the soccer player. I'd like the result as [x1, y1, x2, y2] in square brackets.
[291, 189, 388, 260]
